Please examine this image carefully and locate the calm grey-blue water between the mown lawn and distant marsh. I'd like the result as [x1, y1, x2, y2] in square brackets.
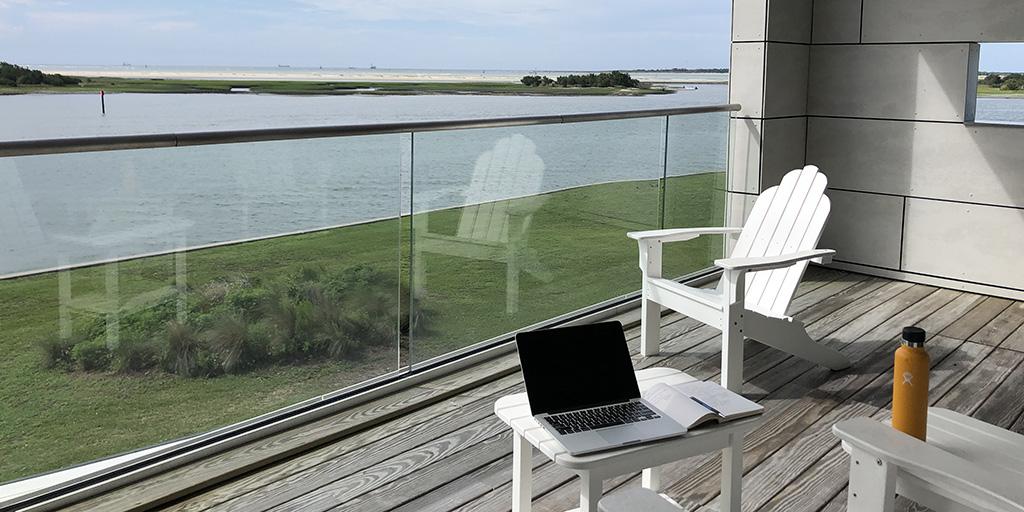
[0, 85, 727, 273]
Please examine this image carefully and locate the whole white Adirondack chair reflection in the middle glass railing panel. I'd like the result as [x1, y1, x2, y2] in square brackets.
[413, 134, 552, 314]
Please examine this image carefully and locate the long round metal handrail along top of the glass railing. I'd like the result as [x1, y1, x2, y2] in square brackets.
[0, 103, 740, 158]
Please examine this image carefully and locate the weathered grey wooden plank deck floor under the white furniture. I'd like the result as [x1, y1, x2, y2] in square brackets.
[64, 268, 1024, 512]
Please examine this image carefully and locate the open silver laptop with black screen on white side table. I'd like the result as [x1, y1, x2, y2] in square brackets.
[515, 322, 686, 455]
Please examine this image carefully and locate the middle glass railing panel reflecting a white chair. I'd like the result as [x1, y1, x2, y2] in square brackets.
[412, 118, 665, 362]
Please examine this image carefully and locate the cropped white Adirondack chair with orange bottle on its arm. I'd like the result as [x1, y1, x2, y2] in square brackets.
[833, 408, 1024, 512]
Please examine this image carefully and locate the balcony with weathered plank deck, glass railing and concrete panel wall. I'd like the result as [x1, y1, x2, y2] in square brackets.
[6, 0, 1024, 511]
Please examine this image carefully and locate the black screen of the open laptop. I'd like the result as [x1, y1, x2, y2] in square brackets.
[515, 322, 640, 415]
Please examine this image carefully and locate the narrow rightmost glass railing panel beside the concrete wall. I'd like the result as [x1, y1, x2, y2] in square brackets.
[664, 113, 729, 278]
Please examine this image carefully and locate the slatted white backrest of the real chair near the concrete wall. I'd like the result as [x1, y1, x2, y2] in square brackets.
[732, 165, 830, 316]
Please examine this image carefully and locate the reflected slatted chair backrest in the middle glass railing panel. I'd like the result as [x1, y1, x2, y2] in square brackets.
[457, 134, 544, 242]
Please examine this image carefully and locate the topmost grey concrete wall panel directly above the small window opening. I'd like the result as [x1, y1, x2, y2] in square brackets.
[868, 0, 1024, 43]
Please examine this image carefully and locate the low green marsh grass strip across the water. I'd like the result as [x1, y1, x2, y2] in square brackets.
[0, 77, 672, 96]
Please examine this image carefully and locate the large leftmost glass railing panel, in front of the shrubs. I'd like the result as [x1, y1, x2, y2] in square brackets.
[0, 135, 409, 481]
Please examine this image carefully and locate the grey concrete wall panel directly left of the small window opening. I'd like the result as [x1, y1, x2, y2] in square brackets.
[811, 43, 974, 121]
